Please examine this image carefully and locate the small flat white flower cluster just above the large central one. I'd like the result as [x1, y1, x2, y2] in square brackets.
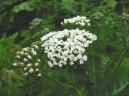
[61, 16, 90, 26]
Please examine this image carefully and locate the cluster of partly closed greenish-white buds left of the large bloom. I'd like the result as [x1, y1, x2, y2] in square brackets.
[13, 44, 41, 77]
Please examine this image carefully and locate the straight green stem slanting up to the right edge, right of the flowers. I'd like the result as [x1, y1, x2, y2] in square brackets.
[103, 48, 127, 88]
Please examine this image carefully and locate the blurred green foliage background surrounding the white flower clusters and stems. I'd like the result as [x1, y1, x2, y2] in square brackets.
[0, 0, 129, 96]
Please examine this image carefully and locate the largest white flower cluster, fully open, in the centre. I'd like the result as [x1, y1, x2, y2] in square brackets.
[41, 29, 97, 67]
